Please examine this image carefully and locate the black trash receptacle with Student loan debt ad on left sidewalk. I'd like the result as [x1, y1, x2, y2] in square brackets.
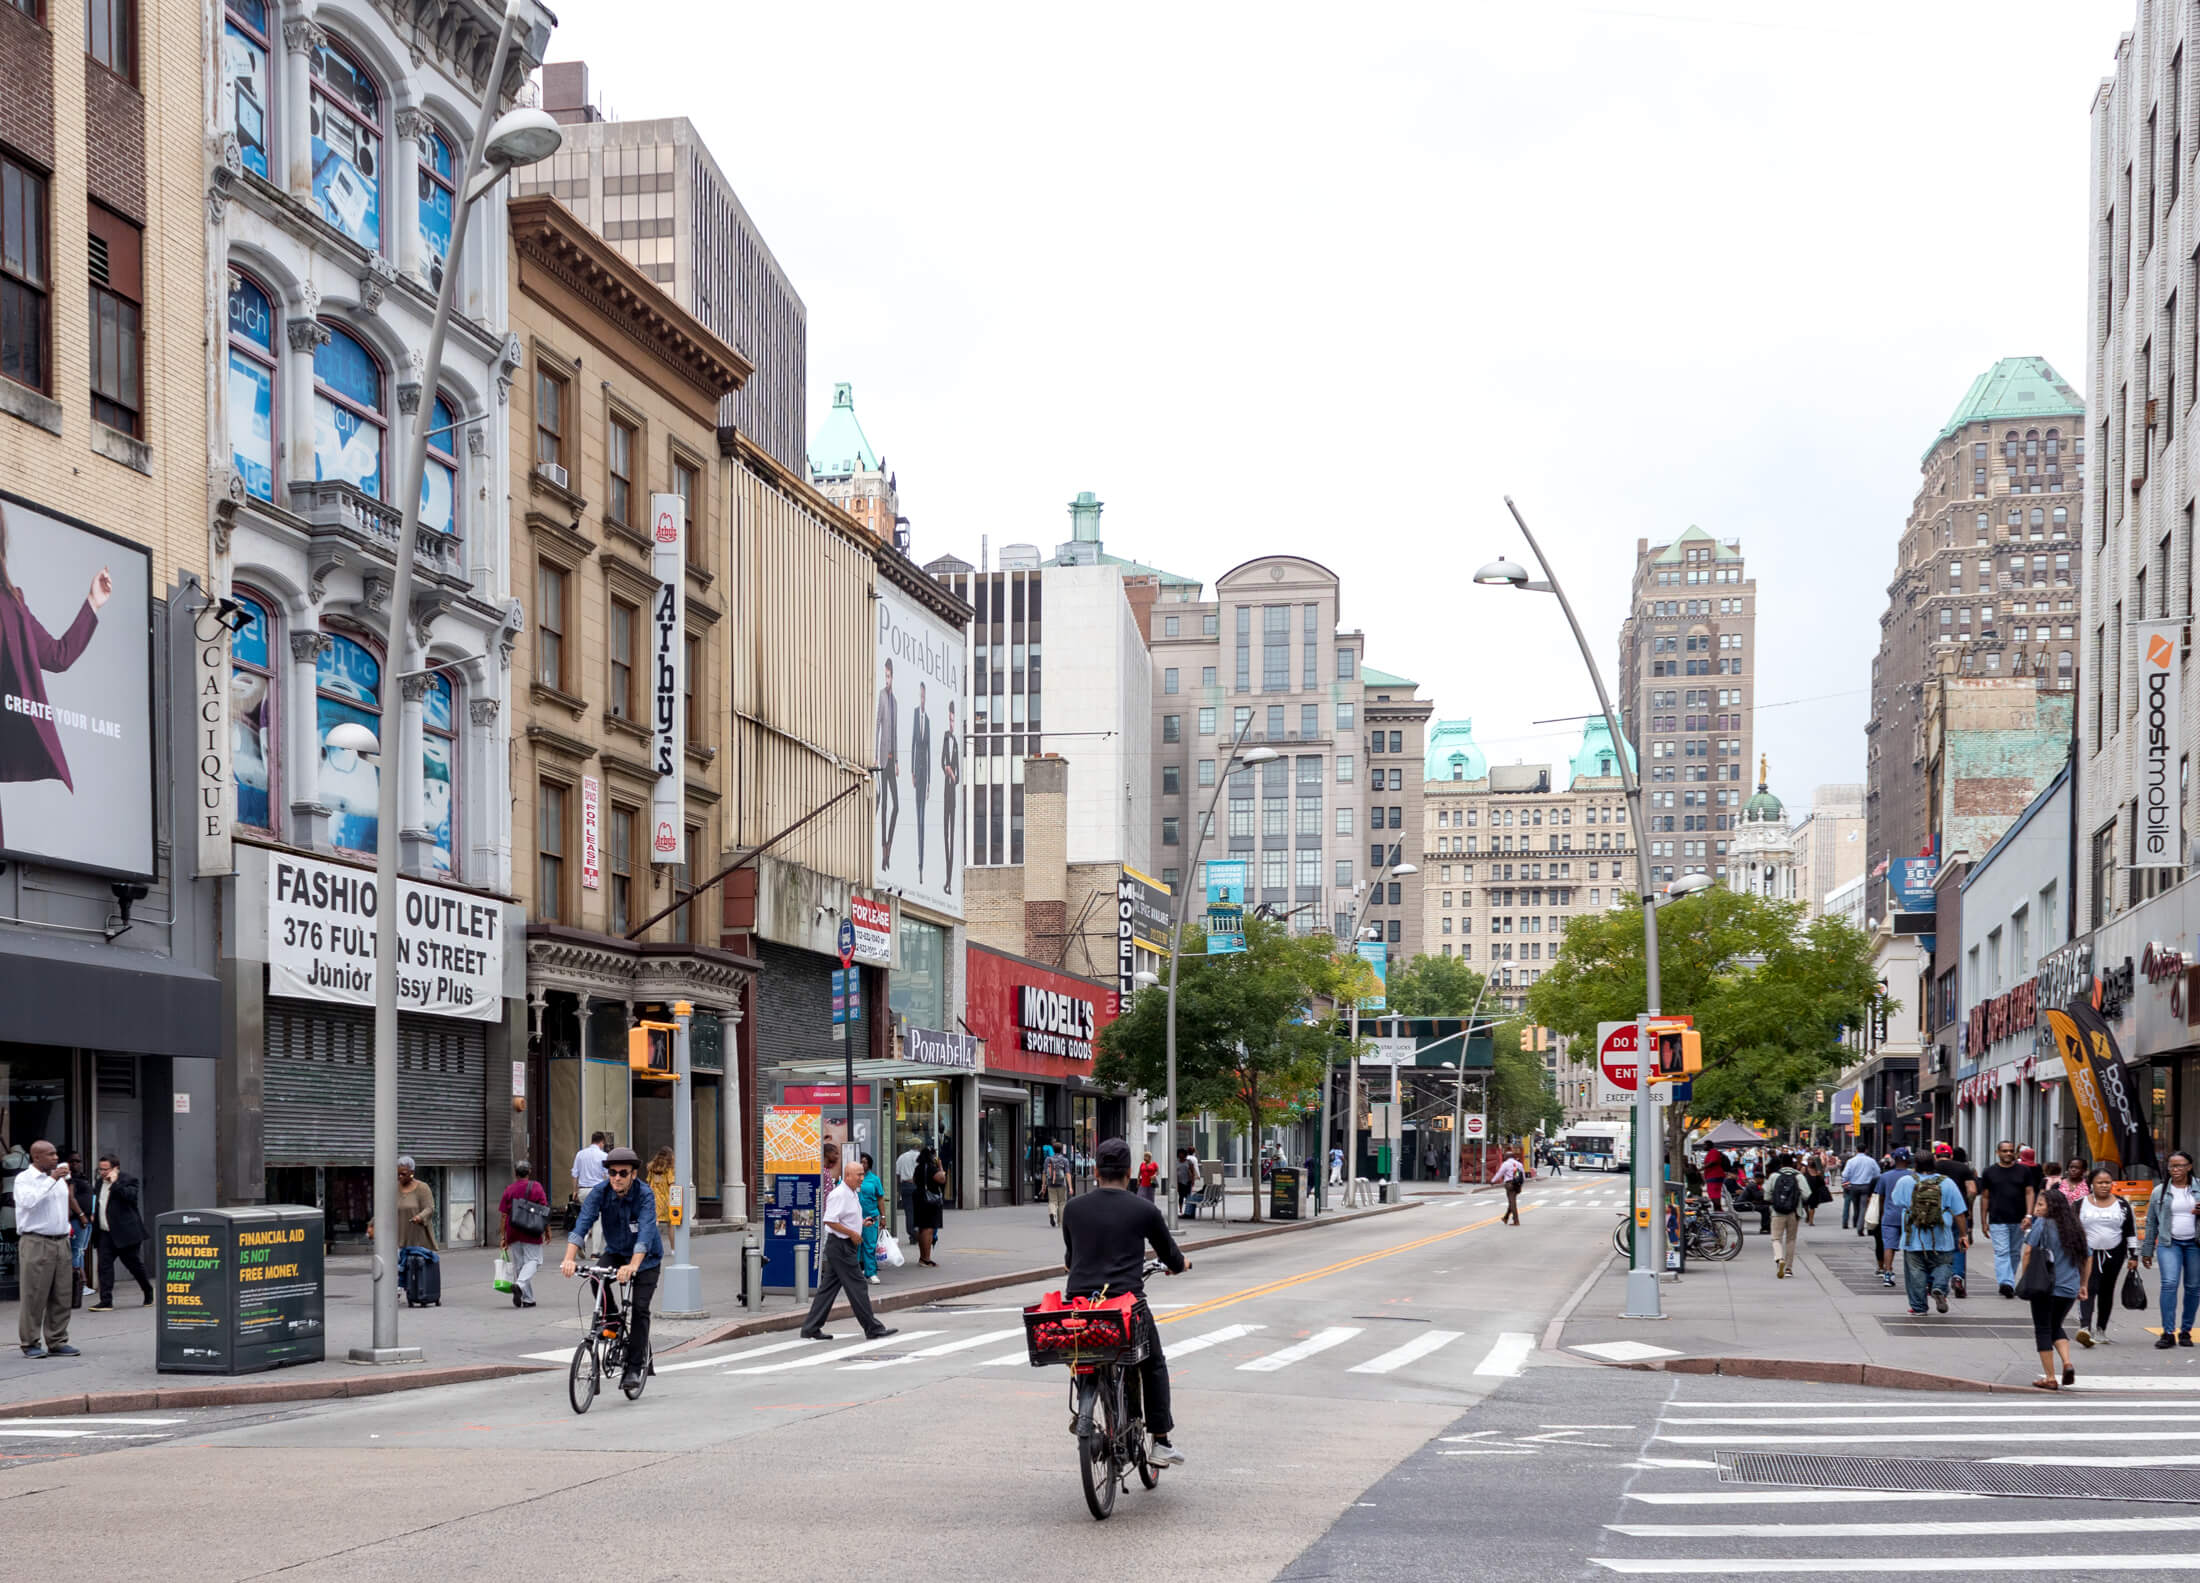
[154, 1205, 328, 1374]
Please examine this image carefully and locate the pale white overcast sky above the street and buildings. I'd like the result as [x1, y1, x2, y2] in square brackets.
[550, 0, 2136, 813]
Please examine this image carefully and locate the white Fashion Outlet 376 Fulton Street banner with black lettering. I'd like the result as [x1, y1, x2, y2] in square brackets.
[268, 853, 504, 1022]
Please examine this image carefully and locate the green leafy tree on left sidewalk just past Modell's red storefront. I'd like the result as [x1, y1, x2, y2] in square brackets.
[1093, 917, 1366, 1220]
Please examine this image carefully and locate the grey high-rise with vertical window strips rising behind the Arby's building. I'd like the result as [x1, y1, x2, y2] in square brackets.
[532, 62, 810, 477]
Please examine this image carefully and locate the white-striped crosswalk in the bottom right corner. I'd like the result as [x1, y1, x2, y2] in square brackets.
[1588, 1381, 2200, 1579]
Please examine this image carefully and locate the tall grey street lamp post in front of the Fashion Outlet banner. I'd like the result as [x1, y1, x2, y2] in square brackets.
[352, 0, 563, 1363]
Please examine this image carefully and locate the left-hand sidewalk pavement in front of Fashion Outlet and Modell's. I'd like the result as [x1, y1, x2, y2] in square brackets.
[0, 1192, 1406, 1416]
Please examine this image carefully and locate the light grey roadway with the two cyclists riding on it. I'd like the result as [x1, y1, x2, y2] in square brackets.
[0, 1178, 1619, 1583]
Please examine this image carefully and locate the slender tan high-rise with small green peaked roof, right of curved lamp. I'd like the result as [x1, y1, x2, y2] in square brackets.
[1619, 528, 1758, 884]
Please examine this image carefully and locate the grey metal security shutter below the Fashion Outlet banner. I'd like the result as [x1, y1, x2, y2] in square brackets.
[264, 1000, 488, 1165]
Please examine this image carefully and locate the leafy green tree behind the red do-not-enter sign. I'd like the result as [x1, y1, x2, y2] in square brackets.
[1527, 886, 1879, 1150]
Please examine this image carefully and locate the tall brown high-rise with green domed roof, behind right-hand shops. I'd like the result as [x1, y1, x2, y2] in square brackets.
[1874, 356, 2086, 890]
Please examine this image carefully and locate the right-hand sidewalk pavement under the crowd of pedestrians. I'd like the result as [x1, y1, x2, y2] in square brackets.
[1544, 1203, 2200, 1392]
